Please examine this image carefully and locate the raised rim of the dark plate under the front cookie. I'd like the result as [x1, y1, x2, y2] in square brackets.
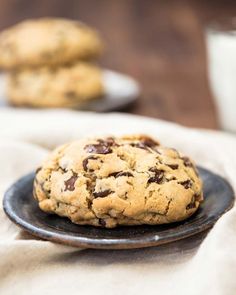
[2, 166, 235, 249]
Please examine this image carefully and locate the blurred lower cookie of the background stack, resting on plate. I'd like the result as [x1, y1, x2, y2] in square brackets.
[6, 62, 103, 107]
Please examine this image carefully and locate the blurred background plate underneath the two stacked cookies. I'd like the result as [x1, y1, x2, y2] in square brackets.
[0, 70, 140, 112]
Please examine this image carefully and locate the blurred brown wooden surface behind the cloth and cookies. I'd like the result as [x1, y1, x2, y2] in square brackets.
[0, 0, 236, 128]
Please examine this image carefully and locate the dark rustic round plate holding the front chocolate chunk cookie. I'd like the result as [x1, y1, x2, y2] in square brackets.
[3, 168, 234, 249]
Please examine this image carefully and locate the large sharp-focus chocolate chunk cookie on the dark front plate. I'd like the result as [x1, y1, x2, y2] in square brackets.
[34, 135, 203, 228]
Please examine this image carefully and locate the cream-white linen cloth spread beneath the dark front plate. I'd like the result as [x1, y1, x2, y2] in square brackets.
[0, 109, 236, 295]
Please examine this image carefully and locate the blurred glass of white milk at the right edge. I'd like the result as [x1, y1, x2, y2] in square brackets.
[206, 18, 236, 132]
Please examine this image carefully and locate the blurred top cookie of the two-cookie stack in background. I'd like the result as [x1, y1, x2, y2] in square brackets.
[0, 18, 103, 69]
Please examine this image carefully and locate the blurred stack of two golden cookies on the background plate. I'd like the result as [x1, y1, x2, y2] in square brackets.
[0, 18, 103, 107]
